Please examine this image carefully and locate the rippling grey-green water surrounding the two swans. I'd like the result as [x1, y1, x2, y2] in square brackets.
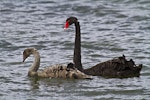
[0, 0, 150, 100]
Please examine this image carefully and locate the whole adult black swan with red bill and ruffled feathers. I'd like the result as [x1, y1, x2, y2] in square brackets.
[64, 17, 142, 78]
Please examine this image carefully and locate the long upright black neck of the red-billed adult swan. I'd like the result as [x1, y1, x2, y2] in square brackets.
[73, 21, 83, 71]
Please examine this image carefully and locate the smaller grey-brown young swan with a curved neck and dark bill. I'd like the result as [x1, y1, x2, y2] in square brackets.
[23, 48, 91, 79]
